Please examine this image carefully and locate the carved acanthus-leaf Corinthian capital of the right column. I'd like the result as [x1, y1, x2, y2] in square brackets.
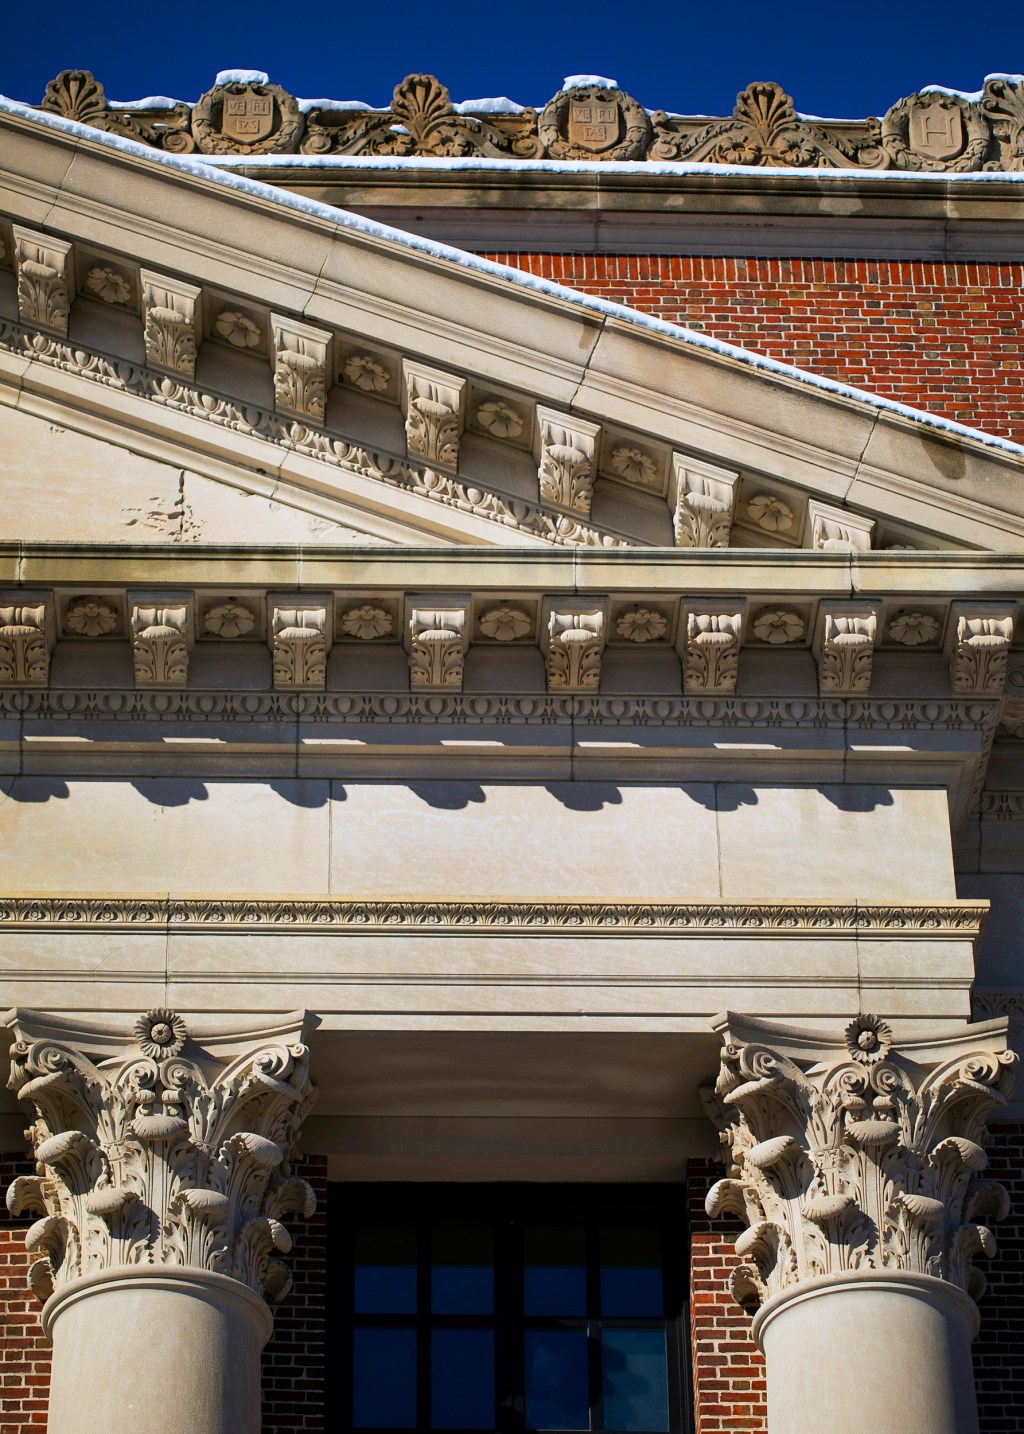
[701, 1012, 1017, 1308]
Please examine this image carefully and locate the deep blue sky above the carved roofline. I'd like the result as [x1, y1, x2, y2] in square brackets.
[0, 0, 1024, 118]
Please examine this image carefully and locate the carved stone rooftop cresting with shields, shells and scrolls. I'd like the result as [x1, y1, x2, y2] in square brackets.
[24, 70, 1024, 174]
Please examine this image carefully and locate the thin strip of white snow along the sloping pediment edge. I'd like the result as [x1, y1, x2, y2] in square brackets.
[0, 95, 1024, 459]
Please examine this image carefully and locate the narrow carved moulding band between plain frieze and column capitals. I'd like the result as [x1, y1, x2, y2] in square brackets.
[0, 893, 988, 940]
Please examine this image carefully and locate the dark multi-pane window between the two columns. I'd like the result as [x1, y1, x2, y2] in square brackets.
[328, 1184, 690, 1434]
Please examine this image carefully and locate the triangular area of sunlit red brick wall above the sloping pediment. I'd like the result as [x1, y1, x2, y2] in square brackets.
[488, 254, 1024, 443]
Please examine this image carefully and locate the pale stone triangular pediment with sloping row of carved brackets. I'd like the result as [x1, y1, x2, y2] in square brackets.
[0, 102, 1024, 552]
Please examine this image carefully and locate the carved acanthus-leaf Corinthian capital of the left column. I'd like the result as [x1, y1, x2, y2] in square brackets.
[6, 1010, 316, 1302]
